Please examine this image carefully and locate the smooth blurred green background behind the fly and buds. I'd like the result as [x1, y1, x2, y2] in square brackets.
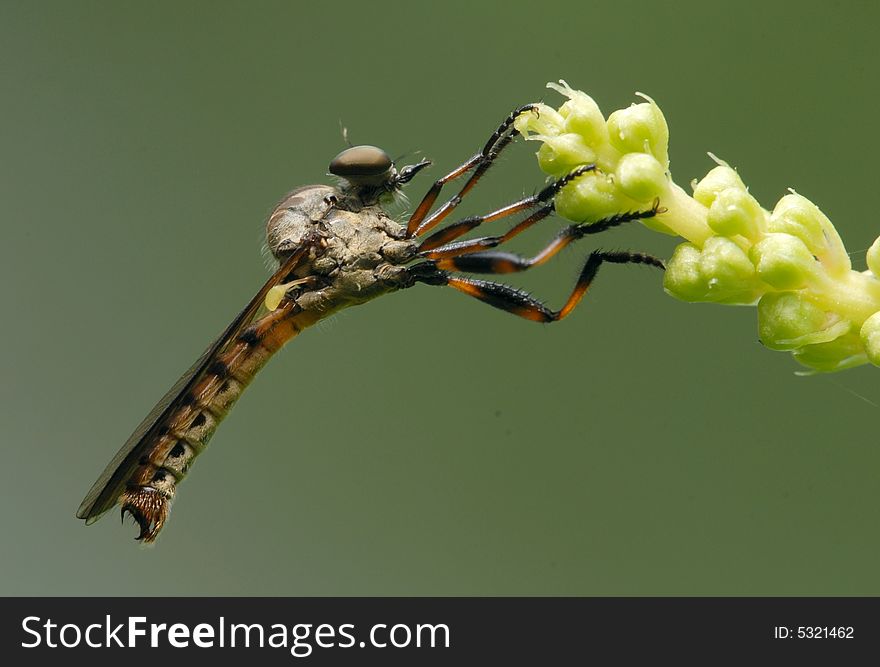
[0, 0, 880, 595]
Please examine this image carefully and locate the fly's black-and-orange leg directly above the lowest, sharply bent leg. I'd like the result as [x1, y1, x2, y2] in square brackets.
[434, 199, 664, 273]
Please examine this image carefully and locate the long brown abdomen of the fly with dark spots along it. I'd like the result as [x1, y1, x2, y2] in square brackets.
[119, 303, 318, 542]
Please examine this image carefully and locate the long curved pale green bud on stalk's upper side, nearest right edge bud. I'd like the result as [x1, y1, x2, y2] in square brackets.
[767, 194, 852, 275]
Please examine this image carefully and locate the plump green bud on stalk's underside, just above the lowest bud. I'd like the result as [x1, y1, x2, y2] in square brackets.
[758, 292, 850, 350]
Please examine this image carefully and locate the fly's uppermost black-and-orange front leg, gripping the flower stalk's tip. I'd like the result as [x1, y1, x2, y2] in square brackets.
[406, 104, 538, 238]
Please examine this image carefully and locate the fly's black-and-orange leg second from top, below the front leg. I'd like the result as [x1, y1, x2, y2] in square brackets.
[418, 164, 596, 253]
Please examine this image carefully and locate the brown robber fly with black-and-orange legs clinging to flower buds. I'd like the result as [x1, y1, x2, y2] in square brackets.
[77, 104, 663, 542]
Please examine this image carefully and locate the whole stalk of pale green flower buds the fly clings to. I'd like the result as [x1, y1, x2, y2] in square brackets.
[516, 81, 880, 372]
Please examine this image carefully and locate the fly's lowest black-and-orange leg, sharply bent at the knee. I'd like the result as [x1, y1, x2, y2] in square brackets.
[412, 250, 664, 322]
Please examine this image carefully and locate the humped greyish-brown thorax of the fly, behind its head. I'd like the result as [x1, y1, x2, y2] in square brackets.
[266, 185, 416, 311]
